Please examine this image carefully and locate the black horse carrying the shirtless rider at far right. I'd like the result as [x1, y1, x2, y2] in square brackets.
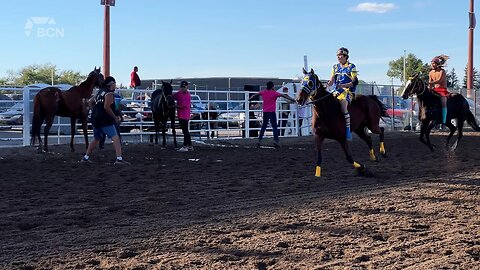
[402, 74, 480, 151]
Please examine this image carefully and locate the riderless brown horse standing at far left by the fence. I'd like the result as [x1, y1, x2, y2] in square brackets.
[31, 67, 104, 152]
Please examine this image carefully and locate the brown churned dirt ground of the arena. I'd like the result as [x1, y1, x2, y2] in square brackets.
[0, 132, 480, 270]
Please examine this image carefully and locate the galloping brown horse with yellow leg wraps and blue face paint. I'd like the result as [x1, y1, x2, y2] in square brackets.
[297, 69, 389, 177]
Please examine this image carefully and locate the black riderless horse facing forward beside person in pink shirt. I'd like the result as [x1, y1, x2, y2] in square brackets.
[150, 81, 177, 147]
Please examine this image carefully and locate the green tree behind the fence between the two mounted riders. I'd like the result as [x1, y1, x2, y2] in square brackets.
[387, 53, 430, 83]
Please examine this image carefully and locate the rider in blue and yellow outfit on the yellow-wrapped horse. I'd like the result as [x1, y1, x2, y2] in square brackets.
[327, 47, 358, 141]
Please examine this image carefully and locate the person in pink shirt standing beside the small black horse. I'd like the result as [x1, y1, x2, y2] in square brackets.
[173, 81, 193, 152]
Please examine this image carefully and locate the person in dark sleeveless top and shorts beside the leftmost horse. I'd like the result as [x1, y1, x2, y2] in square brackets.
[81, 76, 130, 165]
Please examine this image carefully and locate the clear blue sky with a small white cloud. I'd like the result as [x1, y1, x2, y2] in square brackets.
[0, 0, 480, 85]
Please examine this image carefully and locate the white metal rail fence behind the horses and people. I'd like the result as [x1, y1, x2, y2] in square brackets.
[0, 84, 480, 147]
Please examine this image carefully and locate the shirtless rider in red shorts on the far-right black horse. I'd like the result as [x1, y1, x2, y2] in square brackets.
[428, 54, 450, 127]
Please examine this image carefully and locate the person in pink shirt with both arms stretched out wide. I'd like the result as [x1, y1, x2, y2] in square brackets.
[249, 82, 295, 147]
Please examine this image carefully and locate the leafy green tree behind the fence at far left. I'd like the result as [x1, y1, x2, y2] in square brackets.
[4, 64, 86, 85]
